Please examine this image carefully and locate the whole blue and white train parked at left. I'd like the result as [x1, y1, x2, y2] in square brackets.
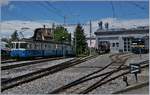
[10, 40, 74, 58]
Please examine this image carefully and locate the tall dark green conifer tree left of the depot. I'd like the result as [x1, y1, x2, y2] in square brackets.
[74, 24, 87, 55]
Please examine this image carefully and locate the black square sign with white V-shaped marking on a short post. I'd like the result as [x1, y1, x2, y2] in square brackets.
[130, 63, 141, 82]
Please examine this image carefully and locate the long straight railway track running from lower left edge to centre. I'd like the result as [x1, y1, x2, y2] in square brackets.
[1, 56, 96, 91]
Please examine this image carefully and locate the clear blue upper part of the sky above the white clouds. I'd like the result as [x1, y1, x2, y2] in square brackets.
[1, 1, 149, 23]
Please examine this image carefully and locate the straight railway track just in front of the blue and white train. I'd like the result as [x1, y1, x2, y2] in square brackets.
[1, 57, 63, 70]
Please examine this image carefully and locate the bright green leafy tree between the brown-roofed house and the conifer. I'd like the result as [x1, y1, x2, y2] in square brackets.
[53, 26, 71, 42]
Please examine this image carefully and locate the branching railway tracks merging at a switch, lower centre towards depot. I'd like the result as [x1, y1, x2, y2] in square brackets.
[48, 54, 144, 94]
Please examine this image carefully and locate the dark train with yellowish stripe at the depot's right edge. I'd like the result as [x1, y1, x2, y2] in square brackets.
[131, 36, 149, 54]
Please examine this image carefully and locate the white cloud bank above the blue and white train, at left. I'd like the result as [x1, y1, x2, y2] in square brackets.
[0, 20, 55, 37]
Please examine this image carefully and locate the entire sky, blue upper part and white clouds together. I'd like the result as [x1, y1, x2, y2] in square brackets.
[0, 0, 149, 36]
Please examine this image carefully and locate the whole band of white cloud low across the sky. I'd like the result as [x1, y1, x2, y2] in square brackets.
[1, 18, 149, 37]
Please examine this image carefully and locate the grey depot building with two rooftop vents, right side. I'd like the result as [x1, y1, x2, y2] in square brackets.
[95, 22, 149, 53]
